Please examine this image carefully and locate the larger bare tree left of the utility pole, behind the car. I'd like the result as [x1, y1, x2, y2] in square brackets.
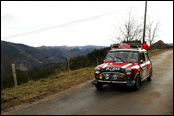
[113, 11, 143, 42]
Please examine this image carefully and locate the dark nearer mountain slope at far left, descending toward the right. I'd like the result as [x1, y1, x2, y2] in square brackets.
[1, 41, 59, 71]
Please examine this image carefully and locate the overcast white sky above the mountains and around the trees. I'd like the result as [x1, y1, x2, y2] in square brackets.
[1, 1, 173, 47]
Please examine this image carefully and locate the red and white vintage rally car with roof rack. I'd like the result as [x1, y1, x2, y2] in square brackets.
[92, 43, 152, 90]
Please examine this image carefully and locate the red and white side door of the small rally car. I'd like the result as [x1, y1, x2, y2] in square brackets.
[140, 52, 147, 80]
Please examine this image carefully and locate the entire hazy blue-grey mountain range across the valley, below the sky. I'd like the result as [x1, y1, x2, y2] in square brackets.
[1, 41, 105, 71]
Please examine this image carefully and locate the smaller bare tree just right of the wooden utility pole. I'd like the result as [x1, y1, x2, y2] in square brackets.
[146, 20, 160, 46]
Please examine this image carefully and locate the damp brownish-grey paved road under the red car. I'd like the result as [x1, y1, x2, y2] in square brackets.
[3, 50, 173, 115]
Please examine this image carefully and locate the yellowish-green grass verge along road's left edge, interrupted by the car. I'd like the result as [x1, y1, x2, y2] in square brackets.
[1, 48, 173, 113]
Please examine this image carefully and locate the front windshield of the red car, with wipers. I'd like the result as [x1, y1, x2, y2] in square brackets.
[106, 51, 138, 62]
